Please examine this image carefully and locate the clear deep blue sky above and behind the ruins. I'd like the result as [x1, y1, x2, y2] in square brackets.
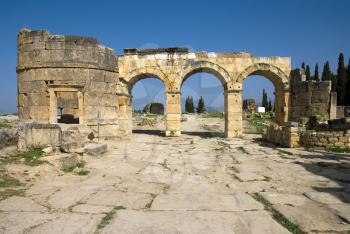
[0, 0, 350, 112]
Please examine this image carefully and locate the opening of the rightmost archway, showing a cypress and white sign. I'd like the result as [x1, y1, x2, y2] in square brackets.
[242, 75, 276, 135]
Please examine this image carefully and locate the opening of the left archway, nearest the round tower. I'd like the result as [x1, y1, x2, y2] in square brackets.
[130, 76, 165, 135]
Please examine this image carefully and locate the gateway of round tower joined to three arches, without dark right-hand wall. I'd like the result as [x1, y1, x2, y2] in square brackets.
[17, 29, 291, 137]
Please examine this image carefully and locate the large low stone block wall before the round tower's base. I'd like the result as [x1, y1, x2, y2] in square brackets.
[18, 123, 62, 151]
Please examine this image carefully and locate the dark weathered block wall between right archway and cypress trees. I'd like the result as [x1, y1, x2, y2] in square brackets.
[290, 71, 331, 122]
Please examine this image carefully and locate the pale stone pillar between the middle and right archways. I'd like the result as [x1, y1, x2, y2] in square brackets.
[224, 89, 242, 138]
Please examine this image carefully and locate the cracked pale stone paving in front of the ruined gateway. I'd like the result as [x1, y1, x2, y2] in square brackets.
[0, 117, 350, 234]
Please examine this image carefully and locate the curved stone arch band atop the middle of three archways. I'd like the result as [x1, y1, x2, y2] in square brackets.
[180, 61, 231, 90]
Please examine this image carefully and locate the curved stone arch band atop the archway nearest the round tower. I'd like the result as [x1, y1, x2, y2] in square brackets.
[122, 67, 173, 93]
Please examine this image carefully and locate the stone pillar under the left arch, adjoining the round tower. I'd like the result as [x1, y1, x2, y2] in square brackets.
[118, 95, 132, 136]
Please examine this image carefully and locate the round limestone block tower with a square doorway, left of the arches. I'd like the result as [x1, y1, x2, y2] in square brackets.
[17, 29, 119, 136]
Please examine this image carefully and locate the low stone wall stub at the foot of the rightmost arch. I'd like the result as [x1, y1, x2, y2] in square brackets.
[262, 125, 300, 148]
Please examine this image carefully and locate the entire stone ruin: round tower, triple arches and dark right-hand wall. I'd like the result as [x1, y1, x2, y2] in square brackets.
[17, 29, 348, 148]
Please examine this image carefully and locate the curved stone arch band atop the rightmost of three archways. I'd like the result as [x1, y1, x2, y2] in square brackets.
[236, 63, 289, 90]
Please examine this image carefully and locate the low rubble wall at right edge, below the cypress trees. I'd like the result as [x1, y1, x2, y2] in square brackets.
[300, 130, 350, 149]
